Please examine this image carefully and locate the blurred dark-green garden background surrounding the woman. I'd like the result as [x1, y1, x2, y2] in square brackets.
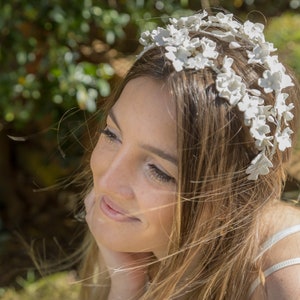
[0, 0, 300, 300]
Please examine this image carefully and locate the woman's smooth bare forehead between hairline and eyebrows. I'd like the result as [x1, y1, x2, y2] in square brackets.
[112, 77, 177, 143]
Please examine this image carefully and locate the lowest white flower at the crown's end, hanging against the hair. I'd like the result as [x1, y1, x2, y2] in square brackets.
[246, 152, 273, 180]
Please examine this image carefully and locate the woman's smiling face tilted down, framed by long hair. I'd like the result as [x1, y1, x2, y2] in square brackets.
[86, 77, 178, 257]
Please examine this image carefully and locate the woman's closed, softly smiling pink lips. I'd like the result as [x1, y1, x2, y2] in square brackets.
[100, 196, 141, 222]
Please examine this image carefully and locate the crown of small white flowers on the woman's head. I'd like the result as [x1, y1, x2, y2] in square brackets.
[139, 11, 294, 180]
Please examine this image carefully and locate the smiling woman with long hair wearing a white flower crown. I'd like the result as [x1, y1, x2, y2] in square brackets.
[82, 11, 300, 300]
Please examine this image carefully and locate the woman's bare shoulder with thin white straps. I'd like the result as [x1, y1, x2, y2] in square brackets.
[263, 203, 300, 300]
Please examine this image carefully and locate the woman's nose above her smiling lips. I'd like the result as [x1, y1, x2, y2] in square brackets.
[91, 149, 135, 200]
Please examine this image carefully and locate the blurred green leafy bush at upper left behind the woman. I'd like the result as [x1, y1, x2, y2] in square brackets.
[0, 0, 190, 125]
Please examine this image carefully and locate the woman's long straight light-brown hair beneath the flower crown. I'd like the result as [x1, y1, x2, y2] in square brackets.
[81, 24, 299, 300]
